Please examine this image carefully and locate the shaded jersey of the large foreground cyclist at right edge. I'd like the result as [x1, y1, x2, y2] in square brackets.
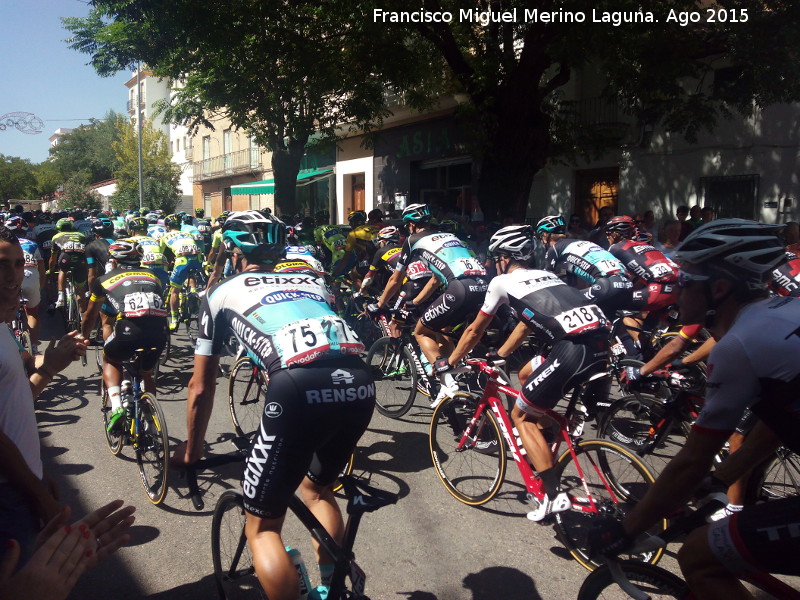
[694, 298, 800, 452]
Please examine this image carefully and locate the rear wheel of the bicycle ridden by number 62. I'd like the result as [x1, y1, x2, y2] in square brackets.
[135, 392, 169, 504]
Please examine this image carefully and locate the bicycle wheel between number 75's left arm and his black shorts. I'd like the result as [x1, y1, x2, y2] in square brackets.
[228, 356, 269, 437]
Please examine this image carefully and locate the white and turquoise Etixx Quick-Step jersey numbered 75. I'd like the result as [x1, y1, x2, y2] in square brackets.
[195, 272, 364, 374]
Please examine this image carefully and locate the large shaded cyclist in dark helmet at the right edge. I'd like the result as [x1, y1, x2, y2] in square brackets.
[590, 219, 800, 600]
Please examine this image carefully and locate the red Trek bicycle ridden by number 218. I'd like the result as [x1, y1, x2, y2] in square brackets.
[429, 359, 666, 570]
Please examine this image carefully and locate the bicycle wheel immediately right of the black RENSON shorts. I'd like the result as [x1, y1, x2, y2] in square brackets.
[365, 336, 418, 419]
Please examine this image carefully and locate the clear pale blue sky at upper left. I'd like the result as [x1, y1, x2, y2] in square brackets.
[0, 0, 132, 163]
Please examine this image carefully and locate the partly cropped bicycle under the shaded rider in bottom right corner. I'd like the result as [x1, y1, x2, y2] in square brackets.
[577, 497, 800, 600]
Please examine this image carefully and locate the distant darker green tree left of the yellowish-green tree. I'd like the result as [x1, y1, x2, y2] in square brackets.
[50, 110, 125, 183]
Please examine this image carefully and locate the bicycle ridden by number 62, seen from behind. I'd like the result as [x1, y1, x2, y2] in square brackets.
[101, 348, 169, 504]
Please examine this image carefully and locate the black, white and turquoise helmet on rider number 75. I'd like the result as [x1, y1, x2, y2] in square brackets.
[222, 210, 286, 262]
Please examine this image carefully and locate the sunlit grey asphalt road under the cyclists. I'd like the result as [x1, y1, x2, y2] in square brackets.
[37, 314, 673, 600]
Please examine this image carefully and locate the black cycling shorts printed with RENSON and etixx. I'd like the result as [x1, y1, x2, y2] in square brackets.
[242, 356, 375, 519]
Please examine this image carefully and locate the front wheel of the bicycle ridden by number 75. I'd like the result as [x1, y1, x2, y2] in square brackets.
[211, 490, 267, 600]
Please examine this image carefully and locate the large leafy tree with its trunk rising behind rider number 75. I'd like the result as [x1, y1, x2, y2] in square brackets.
[64, 0, 428, 212]
